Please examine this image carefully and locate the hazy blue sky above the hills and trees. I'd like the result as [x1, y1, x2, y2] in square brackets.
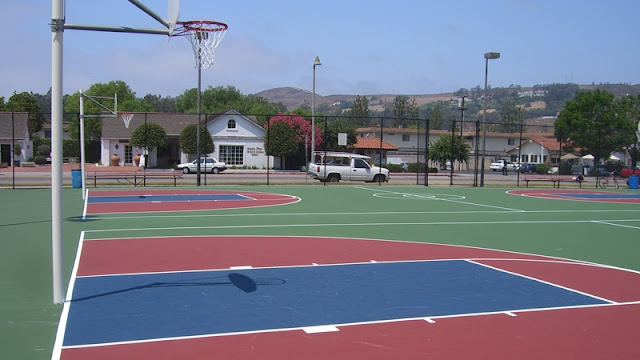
[0, 0, 640, 100]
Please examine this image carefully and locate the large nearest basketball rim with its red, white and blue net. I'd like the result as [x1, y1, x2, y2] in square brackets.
[172, 20, 228, 69]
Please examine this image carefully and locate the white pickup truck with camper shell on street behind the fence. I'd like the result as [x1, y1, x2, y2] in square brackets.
[307, 152, 389, 182]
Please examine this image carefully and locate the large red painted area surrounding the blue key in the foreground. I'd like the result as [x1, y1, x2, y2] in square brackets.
[54, 236, 640, 360]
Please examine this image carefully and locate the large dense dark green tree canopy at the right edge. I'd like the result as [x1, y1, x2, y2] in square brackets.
[555, 89, 637, 160]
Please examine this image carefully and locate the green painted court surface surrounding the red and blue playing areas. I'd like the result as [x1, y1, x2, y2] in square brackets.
[0, 185, 640, 359]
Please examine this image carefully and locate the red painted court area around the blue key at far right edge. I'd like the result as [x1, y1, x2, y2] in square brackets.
[507, 189, 640, 204]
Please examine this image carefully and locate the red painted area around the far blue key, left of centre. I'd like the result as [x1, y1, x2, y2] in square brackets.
[85, 189, 300, 215]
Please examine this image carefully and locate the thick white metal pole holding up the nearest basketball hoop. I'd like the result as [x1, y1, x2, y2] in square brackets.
[51, 0, 65, 304]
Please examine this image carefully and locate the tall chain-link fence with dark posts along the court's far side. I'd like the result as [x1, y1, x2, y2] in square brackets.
[0, 110, 640, 187]
